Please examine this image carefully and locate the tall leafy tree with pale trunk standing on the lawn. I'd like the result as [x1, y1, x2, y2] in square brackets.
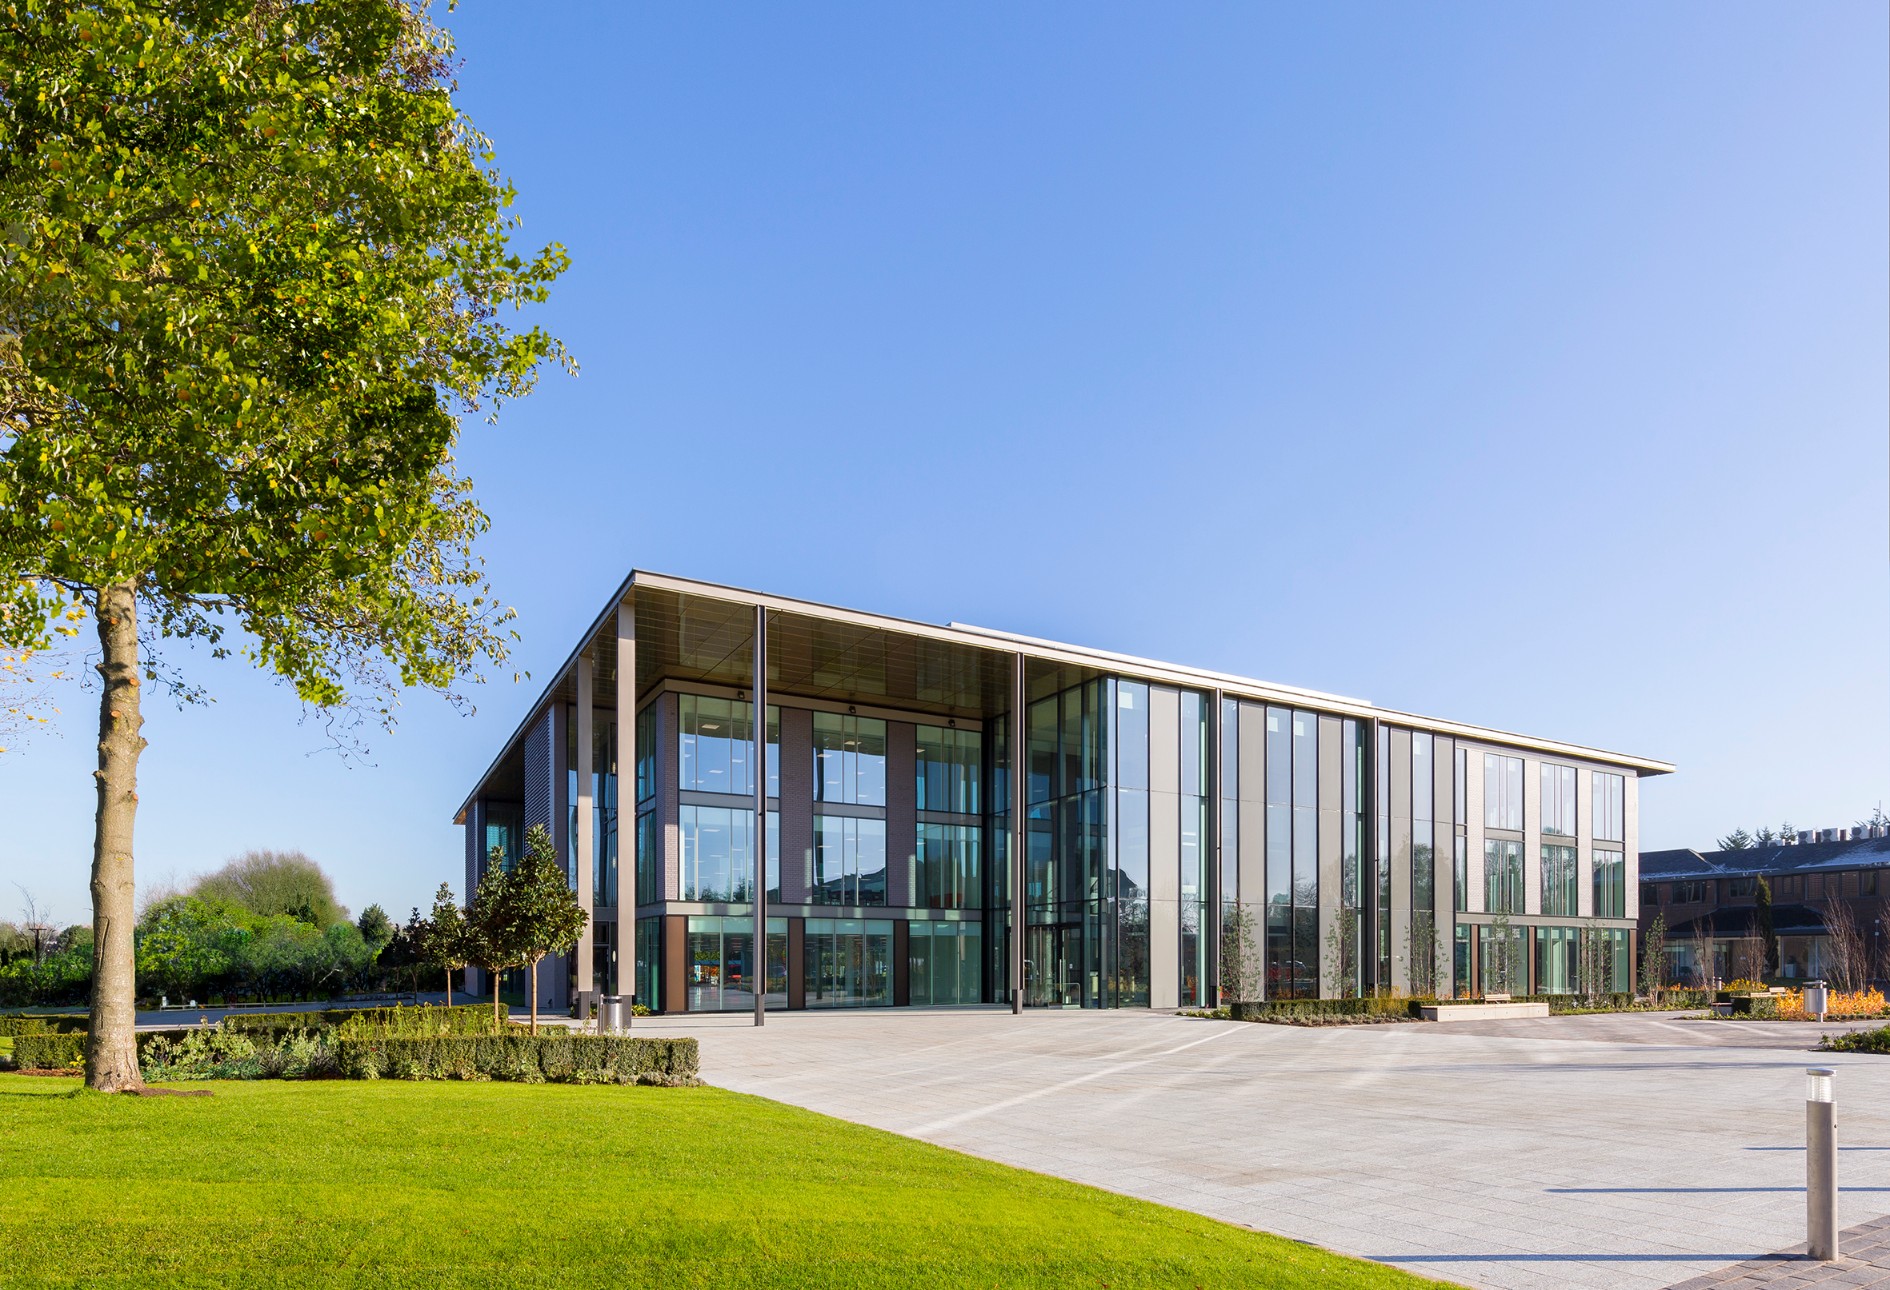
[0, 0, 569, 1090]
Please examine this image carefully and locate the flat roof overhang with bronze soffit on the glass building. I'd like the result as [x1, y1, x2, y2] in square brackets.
[454, 570, 1673, 823]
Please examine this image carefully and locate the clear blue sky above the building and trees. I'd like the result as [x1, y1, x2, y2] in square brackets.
[0, 0, 1890, 922]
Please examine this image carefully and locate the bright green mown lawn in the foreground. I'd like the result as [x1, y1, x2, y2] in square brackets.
[0, 1075, 1435, 1290]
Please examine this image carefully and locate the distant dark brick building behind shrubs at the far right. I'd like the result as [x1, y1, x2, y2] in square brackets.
[1641, 827, 1890, 984]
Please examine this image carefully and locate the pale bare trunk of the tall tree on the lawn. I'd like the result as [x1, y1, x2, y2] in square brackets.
[85, 582, 144, 1094]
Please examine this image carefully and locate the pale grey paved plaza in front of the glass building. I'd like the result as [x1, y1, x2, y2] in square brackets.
[637, 1010, 1890, 1290]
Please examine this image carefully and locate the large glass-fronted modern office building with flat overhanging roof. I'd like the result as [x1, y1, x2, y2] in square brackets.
[455, 572, 1673, 1012]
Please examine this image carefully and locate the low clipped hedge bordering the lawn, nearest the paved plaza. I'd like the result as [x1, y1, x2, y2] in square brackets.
[335, 1035, 699, 1084]
